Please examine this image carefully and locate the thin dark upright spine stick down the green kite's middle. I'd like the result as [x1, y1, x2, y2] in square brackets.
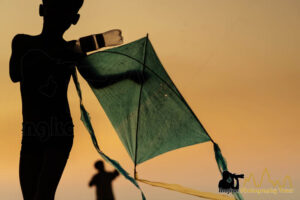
[134, 34, 148, 179]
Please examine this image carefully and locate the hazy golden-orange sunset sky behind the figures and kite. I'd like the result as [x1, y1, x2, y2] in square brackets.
[0, 0, 300, 200]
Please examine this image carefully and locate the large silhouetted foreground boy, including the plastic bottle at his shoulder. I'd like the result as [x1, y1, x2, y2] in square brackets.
[10, 0, 122, 200]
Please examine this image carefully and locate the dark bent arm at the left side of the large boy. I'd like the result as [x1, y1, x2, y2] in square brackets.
[9, 34, 23, 83]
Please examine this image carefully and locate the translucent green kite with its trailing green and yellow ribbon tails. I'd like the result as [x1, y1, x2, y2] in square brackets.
[73, 36, 242, 200]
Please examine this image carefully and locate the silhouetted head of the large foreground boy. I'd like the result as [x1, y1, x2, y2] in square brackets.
[40, 0, 83, 32]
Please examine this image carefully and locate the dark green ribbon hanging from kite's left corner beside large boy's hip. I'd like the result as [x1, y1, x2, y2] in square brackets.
[72, 68, 146, 200]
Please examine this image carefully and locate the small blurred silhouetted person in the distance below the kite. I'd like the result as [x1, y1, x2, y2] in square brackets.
[89, 160, 119, 200]
